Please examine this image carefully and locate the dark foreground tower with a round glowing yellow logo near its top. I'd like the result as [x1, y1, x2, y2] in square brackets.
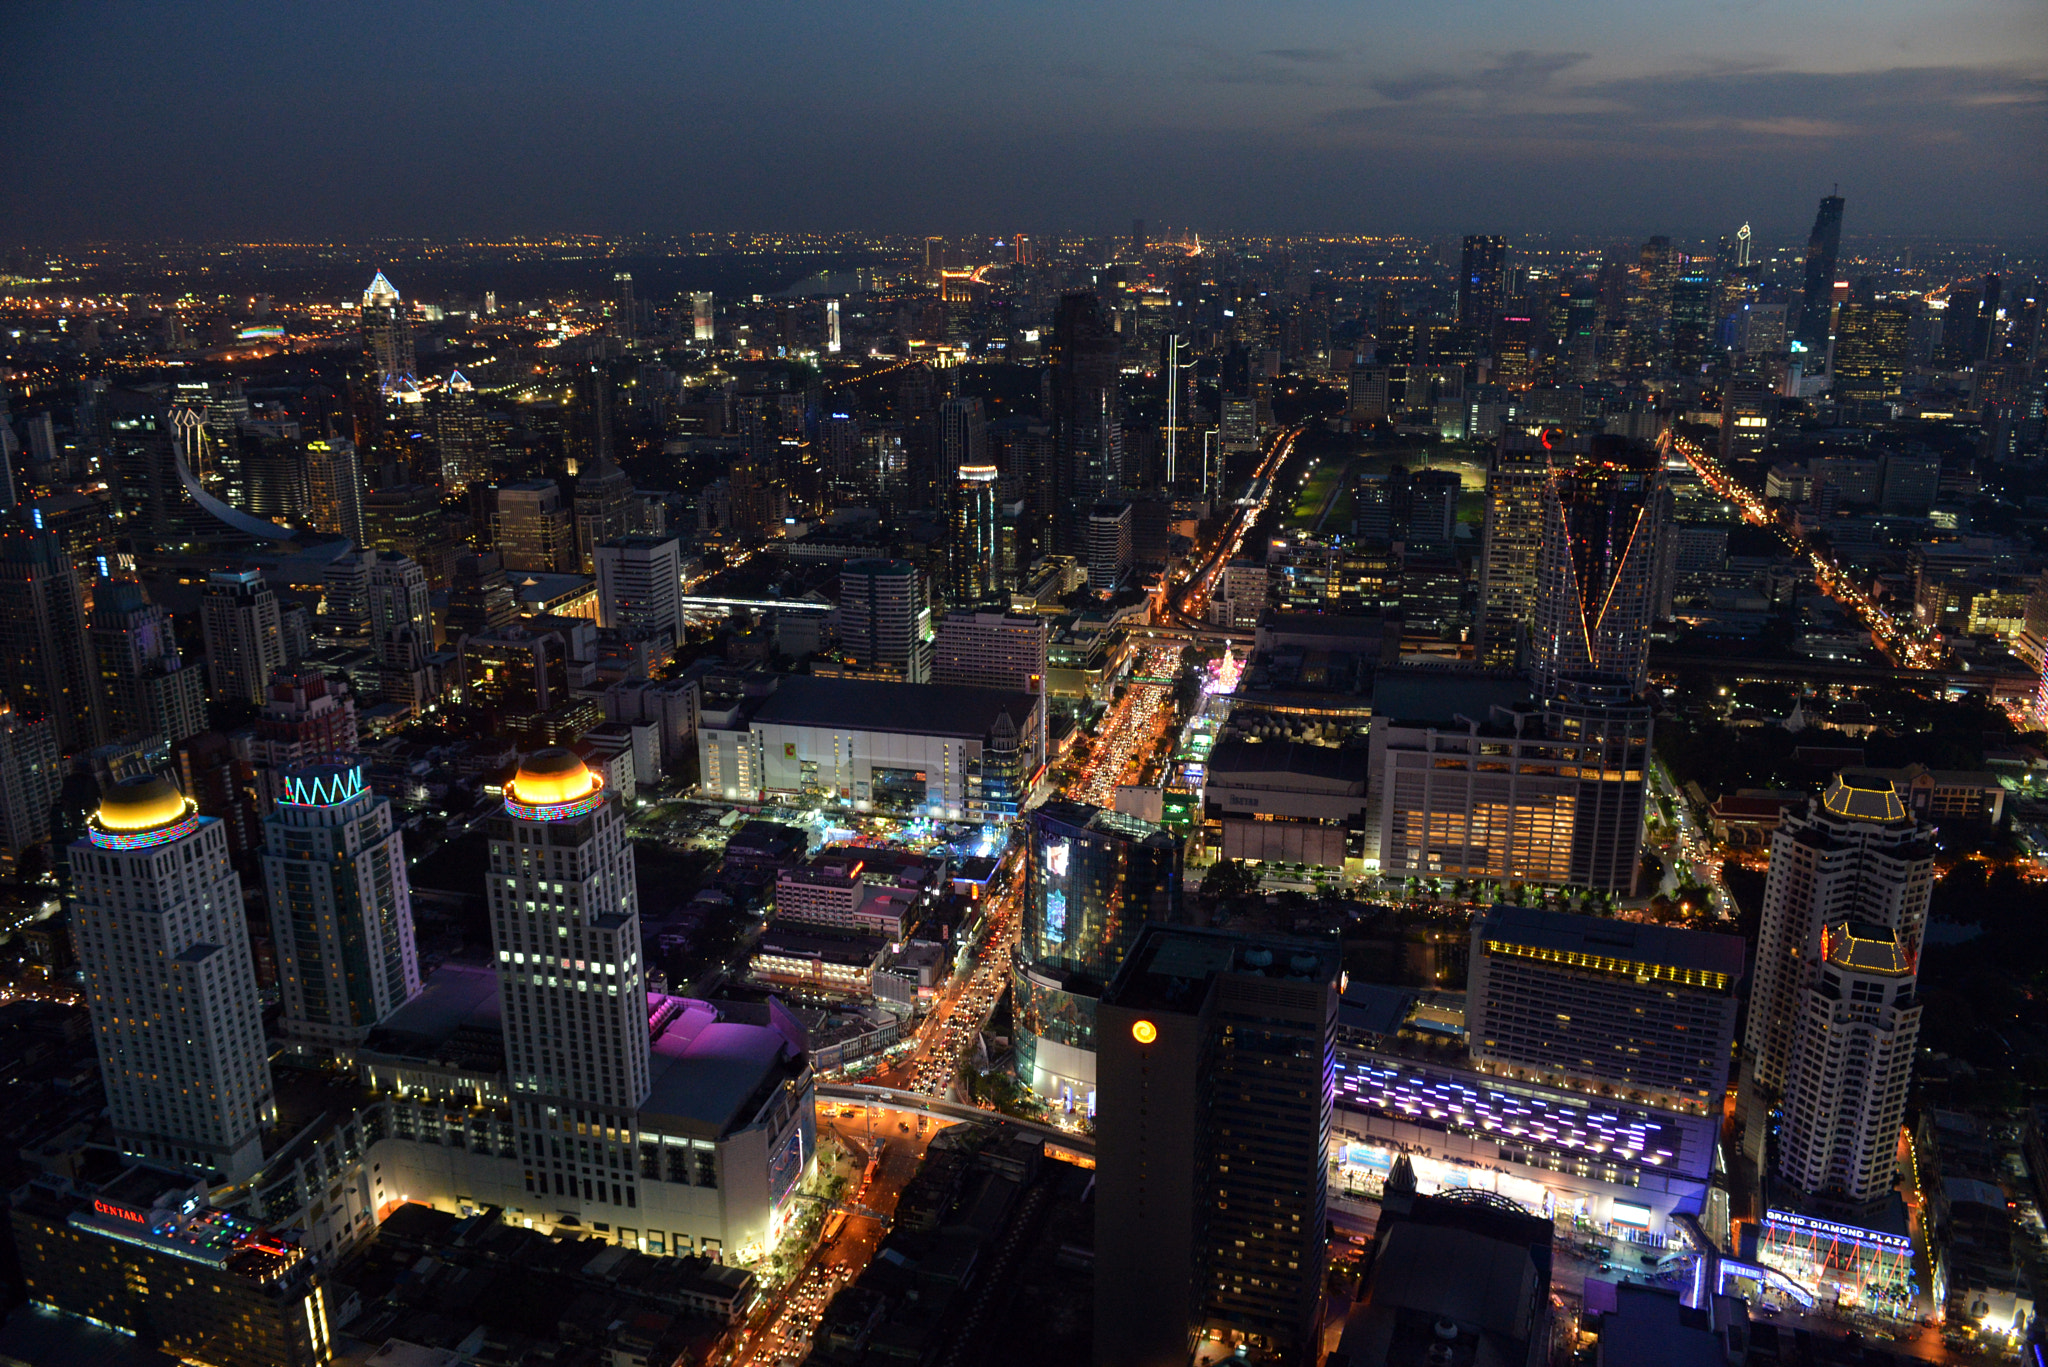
[1096, 924, 1339, 1367]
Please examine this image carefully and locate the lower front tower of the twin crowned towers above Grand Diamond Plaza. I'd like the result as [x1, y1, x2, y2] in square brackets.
[1777, 916, 1921, 1219]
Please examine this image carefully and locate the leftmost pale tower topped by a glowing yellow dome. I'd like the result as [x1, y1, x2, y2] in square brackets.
[72, 777, 274, 1180]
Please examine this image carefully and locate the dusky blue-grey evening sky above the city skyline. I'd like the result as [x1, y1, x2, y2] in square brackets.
[0, 0, 2048, 242]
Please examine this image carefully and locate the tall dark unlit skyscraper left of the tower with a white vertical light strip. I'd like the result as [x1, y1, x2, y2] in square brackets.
[1047, 293, 1124, 555]
